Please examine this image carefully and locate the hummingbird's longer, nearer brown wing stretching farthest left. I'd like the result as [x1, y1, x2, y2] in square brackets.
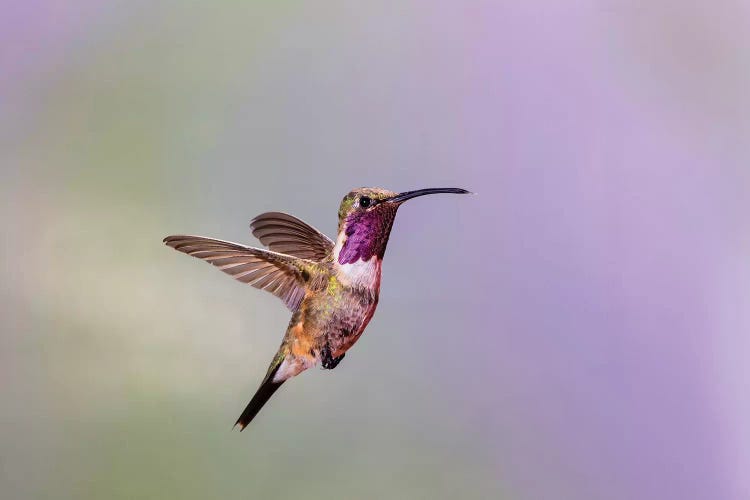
[164, 235, 315, 311]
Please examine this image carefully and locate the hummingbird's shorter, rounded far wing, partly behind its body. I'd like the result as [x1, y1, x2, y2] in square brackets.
[250, 212, 334, 261]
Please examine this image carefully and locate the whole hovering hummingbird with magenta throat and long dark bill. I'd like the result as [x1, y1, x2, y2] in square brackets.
[164, 188, 469, 431]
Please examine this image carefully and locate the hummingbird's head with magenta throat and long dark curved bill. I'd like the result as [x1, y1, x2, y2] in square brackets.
[336, 188, 469, 264]
